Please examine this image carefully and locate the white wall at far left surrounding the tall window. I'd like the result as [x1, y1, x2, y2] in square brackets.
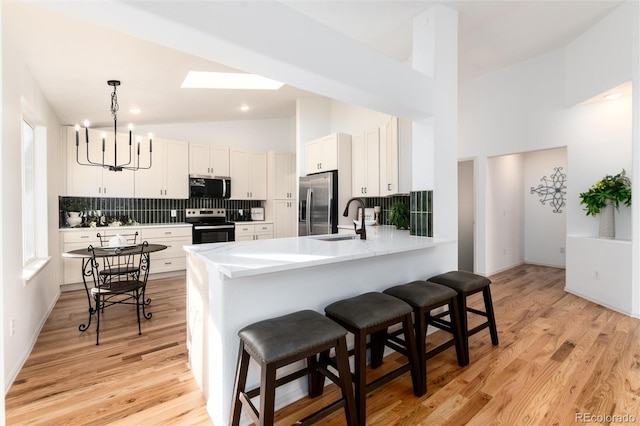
[0, 23, 62, 390]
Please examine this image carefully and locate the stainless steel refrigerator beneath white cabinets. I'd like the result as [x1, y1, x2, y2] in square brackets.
[298, 171, 338, 237]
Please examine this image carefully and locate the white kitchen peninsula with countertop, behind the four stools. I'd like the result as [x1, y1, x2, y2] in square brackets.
[185, 226, 457, 425]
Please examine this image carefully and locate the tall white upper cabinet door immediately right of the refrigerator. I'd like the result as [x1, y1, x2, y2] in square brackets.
[351, 128, 380, 197]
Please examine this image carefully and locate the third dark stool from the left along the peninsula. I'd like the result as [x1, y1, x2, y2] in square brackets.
[384, 281, 466, 390]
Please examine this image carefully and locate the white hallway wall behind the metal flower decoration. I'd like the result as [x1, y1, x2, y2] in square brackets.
[523, 148, 568, 268]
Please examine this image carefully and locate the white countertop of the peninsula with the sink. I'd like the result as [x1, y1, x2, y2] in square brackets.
[184, 226, 453, 278]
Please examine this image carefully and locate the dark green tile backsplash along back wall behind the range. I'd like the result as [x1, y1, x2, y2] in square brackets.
[58, 197, 261, 228]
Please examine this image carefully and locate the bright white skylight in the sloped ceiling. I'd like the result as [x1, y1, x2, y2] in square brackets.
[180, 71, 284, 90]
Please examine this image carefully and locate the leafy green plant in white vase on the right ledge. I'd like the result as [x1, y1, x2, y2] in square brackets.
[580, 169, 631, 238]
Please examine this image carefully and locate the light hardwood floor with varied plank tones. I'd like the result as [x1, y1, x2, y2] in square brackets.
[6, 265, 640, 426]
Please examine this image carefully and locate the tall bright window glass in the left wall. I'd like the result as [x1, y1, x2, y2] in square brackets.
[22, 120, 37, 265]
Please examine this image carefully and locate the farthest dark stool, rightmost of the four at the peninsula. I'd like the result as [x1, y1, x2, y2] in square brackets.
[429, 271, 498, 364]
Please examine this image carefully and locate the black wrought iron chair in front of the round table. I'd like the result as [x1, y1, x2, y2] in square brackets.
[79, 241, 152, 345]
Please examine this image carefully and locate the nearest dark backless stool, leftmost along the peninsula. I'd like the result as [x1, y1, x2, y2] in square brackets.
[229, 310, 357, 426]
